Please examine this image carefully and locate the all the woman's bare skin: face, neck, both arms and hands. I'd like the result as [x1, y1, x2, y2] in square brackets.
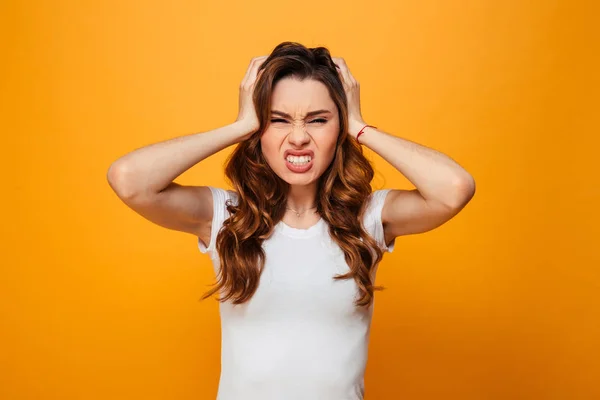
[107, 56, 475, 252]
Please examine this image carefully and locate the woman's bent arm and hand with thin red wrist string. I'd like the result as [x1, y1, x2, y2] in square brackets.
[333, 57, 475, 243]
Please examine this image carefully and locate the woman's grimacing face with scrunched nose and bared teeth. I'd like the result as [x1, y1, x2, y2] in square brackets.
[260, 77, 340, 185]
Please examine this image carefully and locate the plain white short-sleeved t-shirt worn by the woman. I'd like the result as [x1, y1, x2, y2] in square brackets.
[198, 187, 395, 400]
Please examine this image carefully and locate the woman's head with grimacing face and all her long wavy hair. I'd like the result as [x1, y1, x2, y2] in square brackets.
[203, 42, 382, 305]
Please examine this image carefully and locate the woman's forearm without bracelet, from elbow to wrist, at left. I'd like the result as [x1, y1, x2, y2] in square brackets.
[107, 122, 252, 197]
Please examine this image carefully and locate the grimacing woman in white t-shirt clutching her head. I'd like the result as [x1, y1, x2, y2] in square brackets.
[108, 42, 475, 400]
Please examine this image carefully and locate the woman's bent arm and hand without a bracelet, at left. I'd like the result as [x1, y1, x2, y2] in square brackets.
[107, 56, 266, 239]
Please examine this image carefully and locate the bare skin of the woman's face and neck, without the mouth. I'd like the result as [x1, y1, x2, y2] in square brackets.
[261, 77, 340, 228]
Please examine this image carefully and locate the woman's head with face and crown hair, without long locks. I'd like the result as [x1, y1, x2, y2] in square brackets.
[254, 42, 347, 185]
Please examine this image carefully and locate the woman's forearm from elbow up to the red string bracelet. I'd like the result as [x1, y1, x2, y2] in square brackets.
[359, 125, 475, 206]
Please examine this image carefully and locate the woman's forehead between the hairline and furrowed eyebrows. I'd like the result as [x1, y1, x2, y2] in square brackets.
[271, 78, 335, 113]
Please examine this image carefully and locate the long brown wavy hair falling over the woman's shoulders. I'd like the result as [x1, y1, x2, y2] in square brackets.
[202, 42, 384, 306]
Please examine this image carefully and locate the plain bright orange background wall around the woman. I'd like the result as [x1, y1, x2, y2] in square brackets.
[0, 0, 600, 400]
